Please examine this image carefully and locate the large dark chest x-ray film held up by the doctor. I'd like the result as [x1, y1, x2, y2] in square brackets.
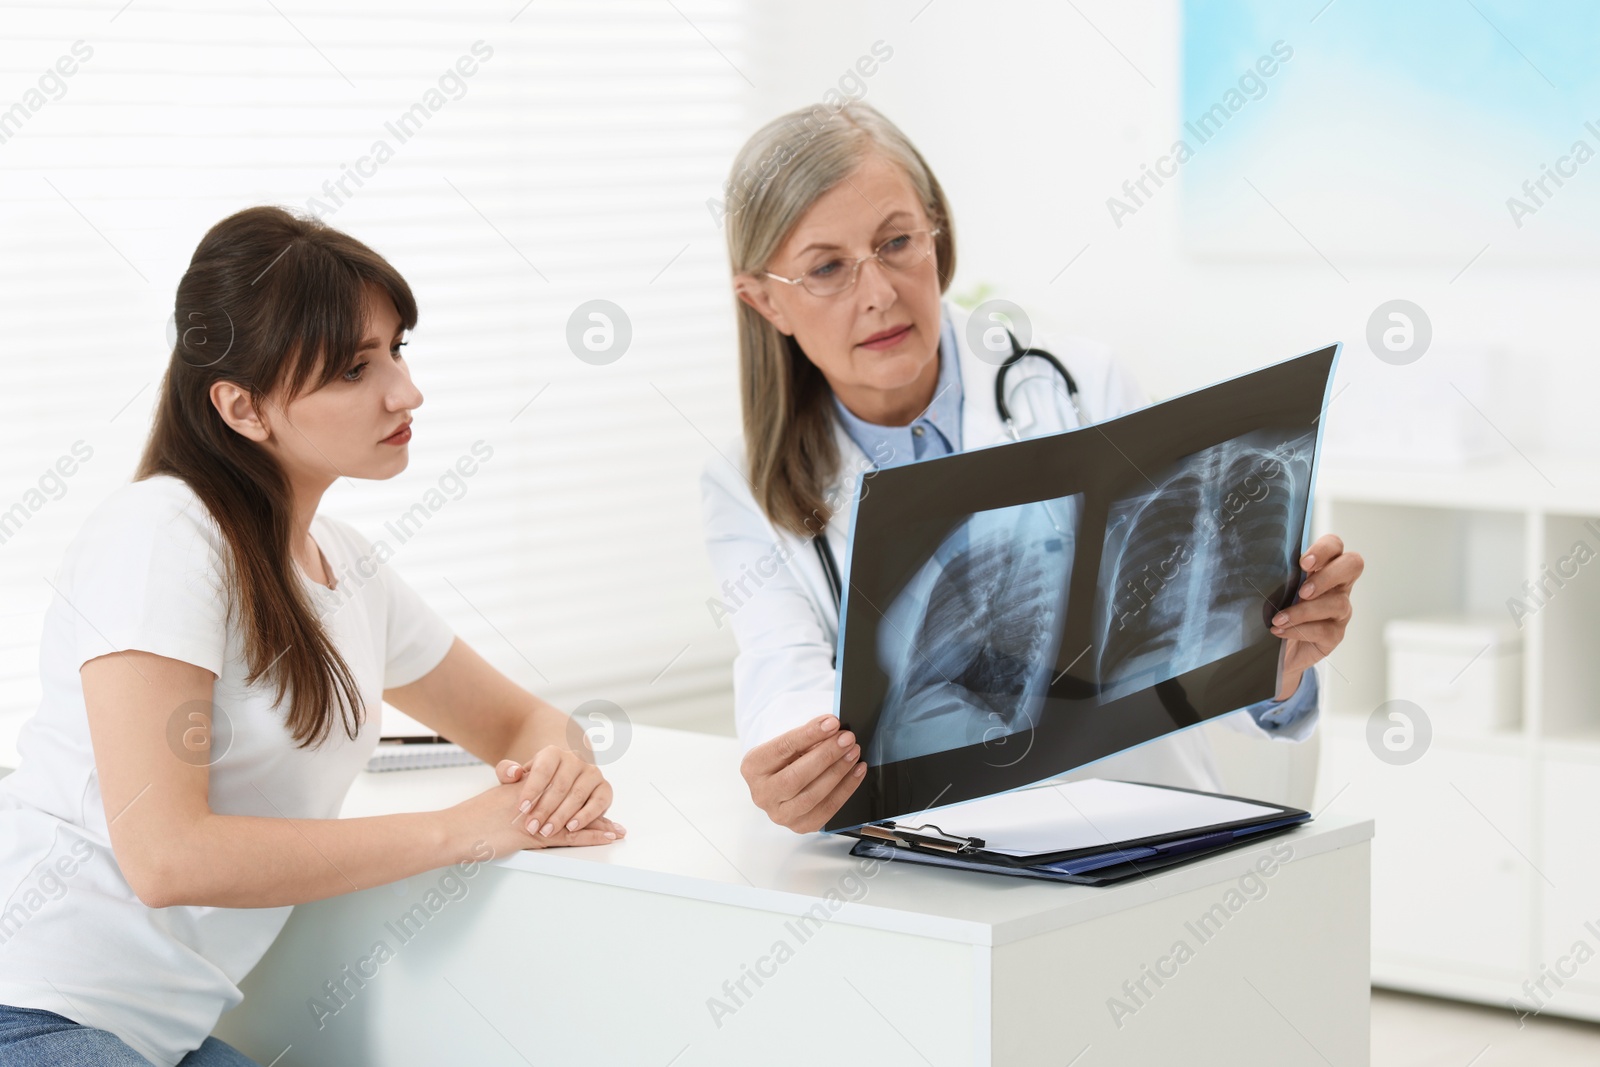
[826, 346, 1338, 830]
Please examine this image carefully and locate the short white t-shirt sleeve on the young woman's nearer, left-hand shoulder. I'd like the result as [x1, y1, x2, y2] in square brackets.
[56, 477, 229, 675]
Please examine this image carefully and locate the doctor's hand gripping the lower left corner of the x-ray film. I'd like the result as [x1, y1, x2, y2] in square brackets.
[739, 715, 867, 833]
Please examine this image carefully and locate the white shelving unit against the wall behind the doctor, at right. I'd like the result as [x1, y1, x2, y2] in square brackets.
[1315, 456, 1600, 1021]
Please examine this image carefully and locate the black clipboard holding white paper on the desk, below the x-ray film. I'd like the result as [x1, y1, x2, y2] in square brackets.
[846, 777, 1310, 885]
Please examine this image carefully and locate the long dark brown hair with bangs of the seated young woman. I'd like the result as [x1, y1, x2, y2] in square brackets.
[134, 206, 416, 747]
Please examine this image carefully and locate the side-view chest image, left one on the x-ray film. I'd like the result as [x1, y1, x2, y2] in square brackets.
[867, 496, 1082, 763]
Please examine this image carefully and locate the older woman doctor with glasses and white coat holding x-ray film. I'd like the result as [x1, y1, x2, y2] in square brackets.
[702, 102, 1362, 832]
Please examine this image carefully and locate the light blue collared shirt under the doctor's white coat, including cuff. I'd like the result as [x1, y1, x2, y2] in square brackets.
[834, 310, 1317, 741]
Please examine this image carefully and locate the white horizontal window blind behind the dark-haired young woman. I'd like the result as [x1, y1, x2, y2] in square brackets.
[0, 0, 746, 765]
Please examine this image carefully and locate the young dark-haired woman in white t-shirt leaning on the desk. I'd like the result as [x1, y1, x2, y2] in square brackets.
[0, 208, 624, 1067]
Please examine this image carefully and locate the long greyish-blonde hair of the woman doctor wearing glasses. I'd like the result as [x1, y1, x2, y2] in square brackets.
[725, 101, 955, 537]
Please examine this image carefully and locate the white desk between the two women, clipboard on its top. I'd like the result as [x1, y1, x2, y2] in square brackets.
[218, 728, 1373, 1067]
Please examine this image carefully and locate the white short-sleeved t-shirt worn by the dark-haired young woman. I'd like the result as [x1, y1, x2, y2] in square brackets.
[0, 477, 453, 1067]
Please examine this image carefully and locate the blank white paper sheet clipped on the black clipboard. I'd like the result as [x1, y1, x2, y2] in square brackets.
[896, 777, 1277, 856]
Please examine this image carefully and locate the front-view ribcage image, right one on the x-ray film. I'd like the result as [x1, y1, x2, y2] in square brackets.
[1094, 430, 1315, 702]
